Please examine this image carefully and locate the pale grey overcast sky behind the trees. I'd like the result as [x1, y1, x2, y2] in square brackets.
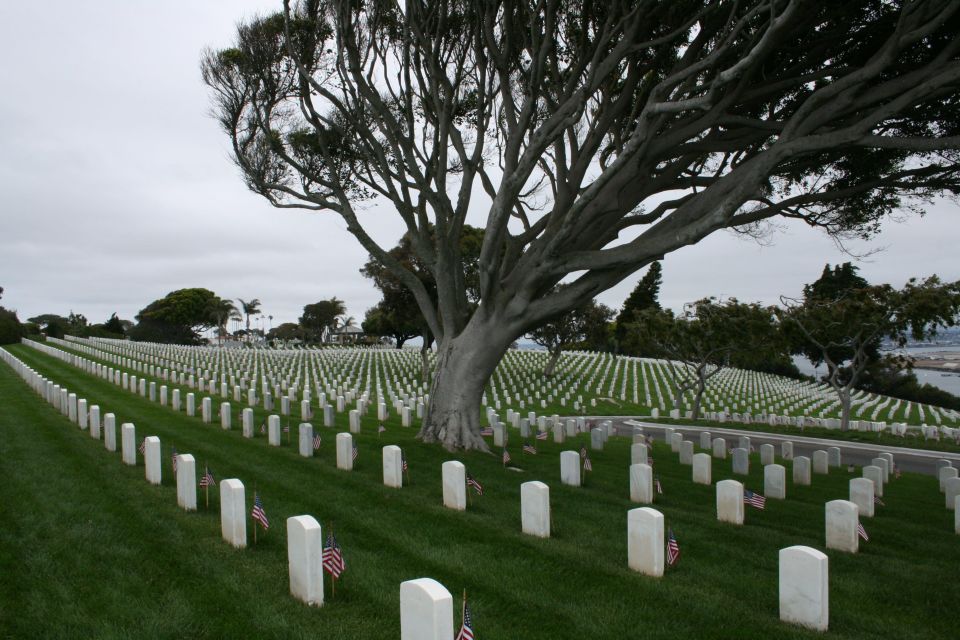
[0, 0, 960, 336]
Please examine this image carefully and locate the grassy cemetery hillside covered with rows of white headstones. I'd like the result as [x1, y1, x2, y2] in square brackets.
[0, 336, 960, 638]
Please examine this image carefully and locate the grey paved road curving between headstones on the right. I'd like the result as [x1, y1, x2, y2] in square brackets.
[588, 416, 960, 475]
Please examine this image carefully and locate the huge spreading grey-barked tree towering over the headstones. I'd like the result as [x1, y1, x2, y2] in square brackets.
[202, 0, 960, 449]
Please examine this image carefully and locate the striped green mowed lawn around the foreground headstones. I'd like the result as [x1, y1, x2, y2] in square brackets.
[0, 346, 960, 640]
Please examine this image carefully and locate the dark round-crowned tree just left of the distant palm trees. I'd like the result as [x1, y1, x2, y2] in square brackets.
[130, 288, 220, 344]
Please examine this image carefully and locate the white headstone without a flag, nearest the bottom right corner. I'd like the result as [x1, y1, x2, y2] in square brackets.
[779, 546, 830, 631]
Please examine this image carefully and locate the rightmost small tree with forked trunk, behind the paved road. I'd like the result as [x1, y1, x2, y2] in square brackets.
[781, 276, 960, 431]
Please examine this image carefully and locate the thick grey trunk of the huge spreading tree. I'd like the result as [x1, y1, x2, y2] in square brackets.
[418, 316, 514, 451]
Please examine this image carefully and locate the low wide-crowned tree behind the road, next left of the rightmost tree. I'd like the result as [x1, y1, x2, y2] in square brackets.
[629, 298, 783, 419]
